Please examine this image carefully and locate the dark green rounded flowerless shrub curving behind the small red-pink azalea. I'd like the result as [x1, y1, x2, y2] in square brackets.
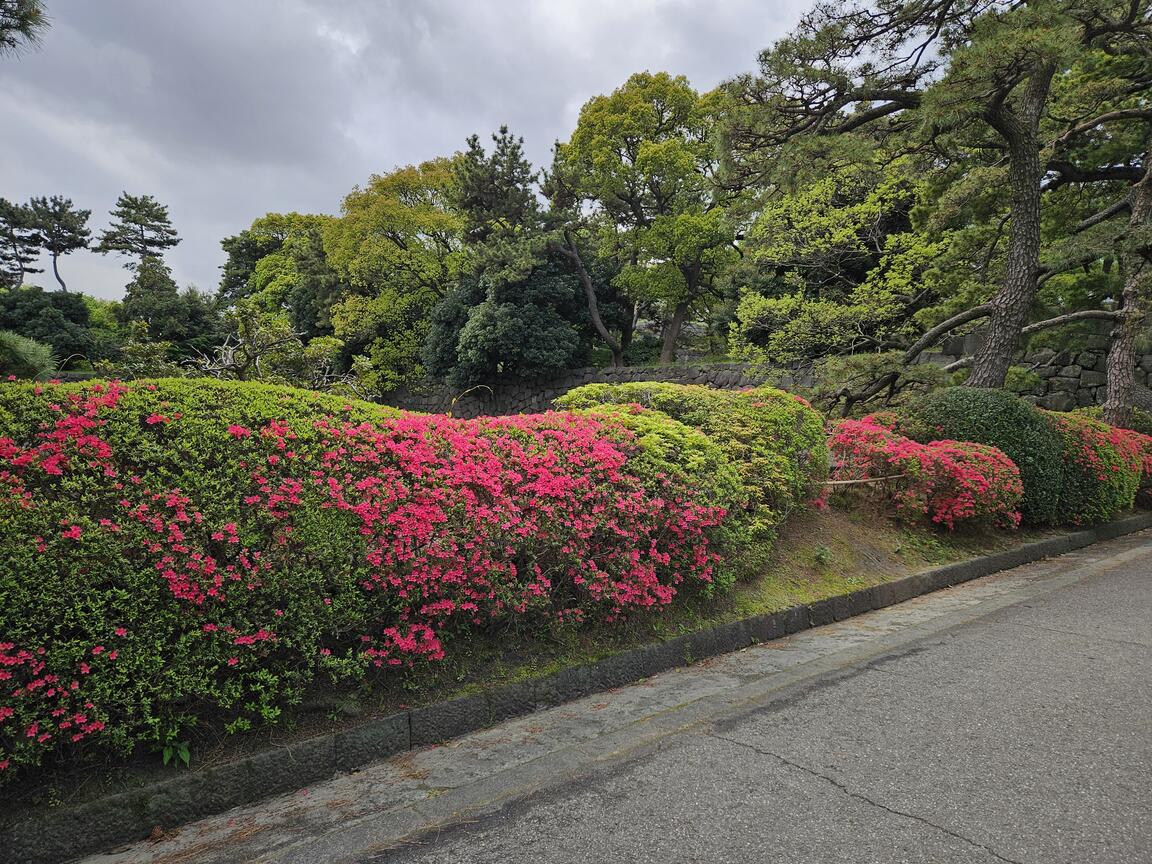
[900, 387, 1064, 525]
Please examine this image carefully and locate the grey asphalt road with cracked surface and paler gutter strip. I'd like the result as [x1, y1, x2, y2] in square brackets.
[90, 533, 1152, 864]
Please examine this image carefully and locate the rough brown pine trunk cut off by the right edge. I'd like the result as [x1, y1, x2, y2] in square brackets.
[1104, 151, 1152, 427]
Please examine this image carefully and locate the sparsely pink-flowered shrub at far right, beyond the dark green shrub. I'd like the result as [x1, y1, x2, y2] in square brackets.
[1040, 411, 1149, 525]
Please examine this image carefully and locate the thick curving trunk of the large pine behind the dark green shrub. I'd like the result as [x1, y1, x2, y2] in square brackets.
[968, 66, 1054, 387]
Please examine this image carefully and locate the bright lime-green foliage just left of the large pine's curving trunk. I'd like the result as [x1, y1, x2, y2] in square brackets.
[730, 152, 942, 363]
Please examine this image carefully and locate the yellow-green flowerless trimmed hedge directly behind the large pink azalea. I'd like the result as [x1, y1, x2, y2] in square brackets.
[553, 381, 828, 574]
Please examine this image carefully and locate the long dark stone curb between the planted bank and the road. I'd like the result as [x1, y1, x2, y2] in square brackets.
[9, 513, 1152, 864]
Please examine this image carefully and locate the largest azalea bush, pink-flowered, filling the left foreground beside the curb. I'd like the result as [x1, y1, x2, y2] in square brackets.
[0, 380, 742, 782]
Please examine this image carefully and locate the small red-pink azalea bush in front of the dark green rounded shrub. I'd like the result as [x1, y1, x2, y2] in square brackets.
[828, 415, 1024, 530]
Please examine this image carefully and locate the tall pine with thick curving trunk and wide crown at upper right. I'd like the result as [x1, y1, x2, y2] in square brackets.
[729, 0, 1152, 387]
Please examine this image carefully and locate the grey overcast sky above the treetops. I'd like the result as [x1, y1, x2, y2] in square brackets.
[0, 0, 809, 297]
